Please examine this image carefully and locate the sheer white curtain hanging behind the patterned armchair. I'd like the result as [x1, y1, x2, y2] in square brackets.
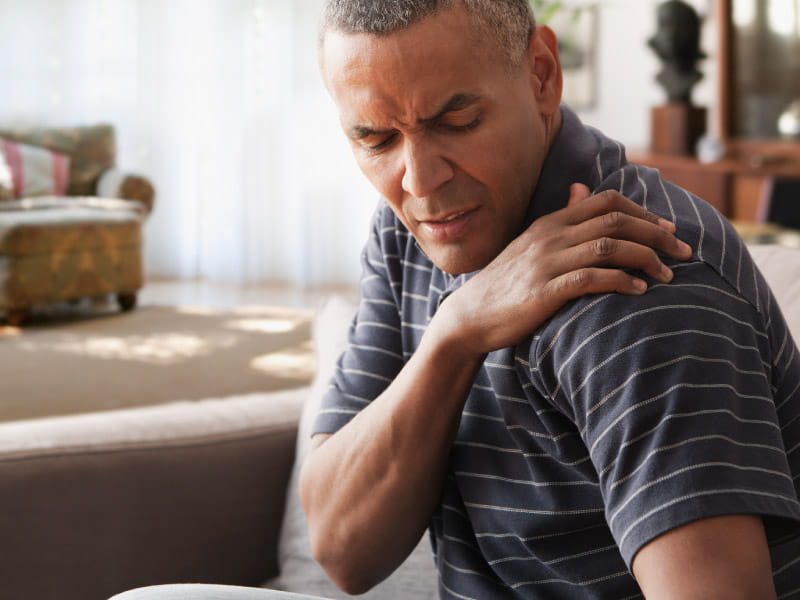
[0, 0, 377, 286]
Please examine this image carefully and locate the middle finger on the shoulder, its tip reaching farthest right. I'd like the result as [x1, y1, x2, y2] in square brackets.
[569, 207, 692, 260]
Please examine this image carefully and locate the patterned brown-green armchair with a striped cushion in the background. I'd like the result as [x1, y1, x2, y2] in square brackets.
[0, 124, 155, 326]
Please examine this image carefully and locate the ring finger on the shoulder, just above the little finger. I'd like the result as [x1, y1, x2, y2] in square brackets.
[559, 237, 674, 283]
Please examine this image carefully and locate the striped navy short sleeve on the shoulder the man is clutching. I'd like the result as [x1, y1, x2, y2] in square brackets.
[535, 262, 800, 567]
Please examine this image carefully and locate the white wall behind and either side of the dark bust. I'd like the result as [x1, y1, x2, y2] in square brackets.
[580, 0, 717, 149]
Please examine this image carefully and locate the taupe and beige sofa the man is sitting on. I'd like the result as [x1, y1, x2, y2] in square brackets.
[0, 245, 800, 600]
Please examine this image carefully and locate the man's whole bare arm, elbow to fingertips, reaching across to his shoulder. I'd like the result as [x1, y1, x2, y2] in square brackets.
[300, 190, 691, 593]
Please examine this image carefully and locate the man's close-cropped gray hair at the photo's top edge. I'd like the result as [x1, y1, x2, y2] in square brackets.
[320, 0, 536, 67]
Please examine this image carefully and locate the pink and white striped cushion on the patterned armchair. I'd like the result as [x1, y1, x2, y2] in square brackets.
[0, 139, 70, 198]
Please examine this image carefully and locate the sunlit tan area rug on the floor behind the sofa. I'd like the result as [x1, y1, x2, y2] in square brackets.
[0, 306, 314, 421]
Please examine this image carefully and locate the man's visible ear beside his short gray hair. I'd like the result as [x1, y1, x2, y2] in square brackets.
[528, 25, 564, 114]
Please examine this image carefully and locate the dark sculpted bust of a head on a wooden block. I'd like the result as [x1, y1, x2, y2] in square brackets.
[648, 0, 706, 105]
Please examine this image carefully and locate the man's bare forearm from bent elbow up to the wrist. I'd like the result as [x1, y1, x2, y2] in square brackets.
[301, 312, 482, 593]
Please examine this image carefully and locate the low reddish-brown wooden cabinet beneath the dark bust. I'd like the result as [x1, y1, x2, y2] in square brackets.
[628, 151, 800, 222]
